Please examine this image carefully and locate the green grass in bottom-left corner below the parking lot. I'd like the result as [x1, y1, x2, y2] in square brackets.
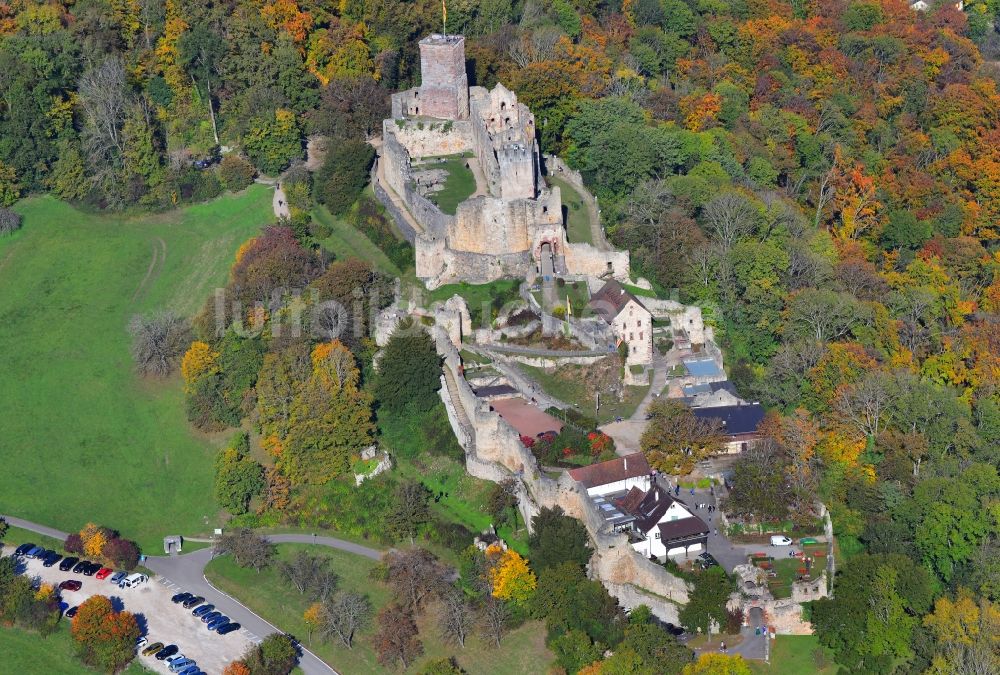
[0, 622, 149, 675]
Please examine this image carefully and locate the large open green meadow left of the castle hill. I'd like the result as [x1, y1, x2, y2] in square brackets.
[0, 186, 273, 551]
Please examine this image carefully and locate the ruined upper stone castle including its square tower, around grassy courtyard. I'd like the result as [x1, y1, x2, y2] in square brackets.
[375, 35, 629, 288]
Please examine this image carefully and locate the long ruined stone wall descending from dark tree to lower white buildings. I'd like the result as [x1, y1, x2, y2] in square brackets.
[433, 327, 688, 623]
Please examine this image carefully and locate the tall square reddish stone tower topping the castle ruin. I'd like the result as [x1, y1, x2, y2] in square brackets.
[415, 34, 469, 120]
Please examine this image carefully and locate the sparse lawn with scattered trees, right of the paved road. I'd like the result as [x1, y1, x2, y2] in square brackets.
[206, 544, 553, 675]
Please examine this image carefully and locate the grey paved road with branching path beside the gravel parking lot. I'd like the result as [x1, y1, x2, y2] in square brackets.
[2, 516, 382, 675]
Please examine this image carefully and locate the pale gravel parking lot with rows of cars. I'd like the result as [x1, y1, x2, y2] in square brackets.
[3, 546, 259, 675]
